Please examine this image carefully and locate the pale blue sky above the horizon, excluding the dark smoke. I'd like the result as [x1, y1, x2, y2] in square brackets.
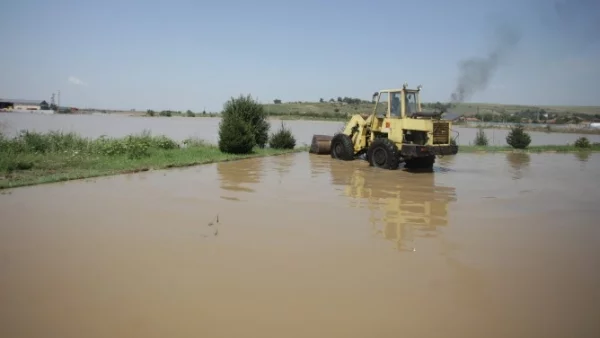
[0, 0, 600, 111]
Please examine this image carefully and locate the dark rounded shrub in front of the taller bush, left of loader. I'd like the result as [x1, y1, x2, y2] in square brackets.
[219, 115, 256, 154]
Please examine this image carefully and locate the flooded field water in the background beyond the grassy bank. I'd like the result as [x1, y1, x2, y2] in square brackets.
[0, 113, 600, 146]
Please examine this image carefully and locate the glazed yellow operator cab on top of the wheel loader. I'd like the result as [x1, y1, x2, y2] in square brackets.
[373, 84, 421, 119]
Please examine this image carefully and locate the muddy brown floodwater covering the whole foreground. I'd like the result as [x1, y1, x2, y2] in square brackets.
[0, 153, 600, 338]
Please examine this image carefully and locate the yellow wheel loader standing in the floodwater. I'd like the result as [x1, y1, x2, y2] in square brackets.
[310, 84, 458, 170]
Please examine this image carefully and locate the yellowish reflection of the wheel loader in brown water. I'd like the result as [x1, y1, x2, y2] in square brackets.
[330, 161, 456, 251]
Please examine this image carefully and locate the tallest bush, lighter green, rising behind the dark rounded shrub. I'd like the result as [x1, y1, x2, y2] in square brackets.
[222, 95, 270, 148]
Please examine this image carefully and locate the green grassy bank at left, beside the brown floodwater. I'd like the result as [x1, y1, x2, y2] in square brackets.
[0, 132, 307, 189]
